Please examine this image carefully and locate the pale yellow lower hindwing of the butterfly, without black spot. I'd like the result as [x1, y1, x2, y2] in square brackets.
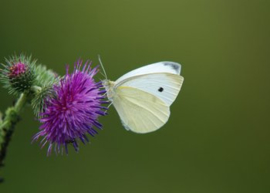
[113, 86, 170, 133]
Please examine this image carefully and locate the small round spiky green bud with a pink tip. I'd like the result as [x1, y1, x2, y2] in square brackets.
[0, 55, 35, 94]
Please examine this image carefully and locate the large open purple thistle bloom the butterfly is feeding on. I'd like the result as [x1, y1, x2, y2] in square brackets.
[33, 60, 107, 155]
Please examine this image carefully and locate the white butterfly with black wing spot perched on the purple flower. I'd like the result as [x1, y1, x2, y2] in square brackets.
[103, 62, 184, 133]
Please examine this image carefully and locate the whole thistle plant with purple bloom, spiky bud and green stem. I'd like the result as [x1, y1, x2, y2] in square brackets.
[0, 54, 108, 182]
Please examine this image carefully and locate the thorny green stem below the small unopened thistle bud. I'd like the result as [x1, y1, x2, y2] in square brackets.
[0, 93, 27, 183]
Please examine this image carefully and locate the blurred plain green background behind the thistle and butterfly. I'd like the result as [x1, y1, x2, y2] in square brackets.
[0, 0, 270, 193]
